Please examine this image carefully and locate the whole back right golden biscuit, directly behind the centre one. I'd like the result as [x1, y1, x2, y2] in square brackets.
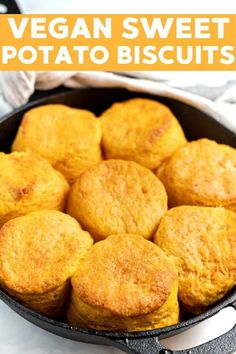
[100, 98, 186, 170]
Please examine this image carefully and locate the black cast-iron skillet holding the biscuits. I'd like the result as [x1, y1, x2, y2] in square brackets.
[0, 88, 236, 354]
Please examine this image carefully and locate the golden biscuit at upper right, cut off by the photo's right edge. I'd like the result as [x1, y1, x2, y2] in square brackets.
[157, 139, 236, 211]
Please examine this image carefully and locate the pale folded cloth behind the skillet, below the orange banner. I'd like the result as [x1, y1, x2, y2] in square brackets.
[0, 71, 236, 133]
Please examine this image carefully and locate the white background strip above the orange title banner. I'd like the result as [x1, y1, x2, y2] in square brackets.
[18, 0, 236, 14]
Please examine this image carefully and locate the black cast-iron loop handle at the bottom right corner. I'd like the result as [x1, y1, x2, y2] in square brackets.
[114, 302, 236, 354]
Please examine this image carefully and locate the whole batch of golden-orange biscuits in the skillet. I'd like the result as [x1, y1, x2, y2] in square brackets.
[0, 98, 236, 331]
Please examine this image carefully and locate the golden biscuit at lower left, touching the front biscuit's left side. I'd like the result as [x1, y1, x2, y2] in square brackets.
[0, 210, 93, 317]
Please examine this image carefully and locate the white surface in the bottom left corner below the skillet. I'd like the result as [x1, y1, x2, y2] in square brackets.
[0, 302, 121, 354]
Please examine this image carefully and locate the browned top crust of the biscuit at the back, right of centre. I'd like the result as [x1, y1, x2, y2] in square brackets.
[100, 98, 175, 154]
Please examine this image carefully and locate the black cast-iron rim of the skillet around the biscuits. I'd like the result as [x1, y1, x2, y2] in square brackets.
[0, 88, 236, 339]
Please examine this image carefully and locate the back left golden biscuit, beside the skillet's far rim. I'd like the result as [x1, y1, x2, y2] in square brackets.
[12, 104, 102, 183]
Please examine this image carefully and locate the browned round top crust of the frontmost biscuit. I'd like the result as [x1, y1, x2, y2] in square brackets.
[72, 234, 177, 316]
